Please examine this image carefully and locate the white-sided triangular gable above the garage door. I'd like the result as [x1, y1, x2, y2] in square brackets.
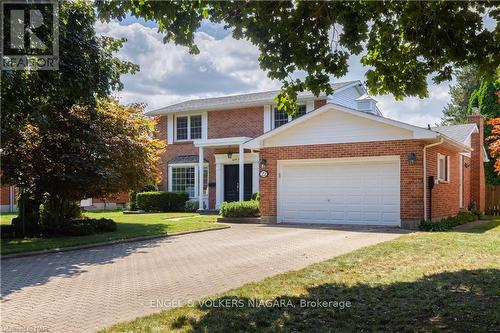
[264, 110, 413, 147]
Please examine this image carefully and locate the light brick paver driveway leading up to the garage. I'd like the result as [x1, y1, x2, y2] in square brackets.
[1, 225, 403, 333]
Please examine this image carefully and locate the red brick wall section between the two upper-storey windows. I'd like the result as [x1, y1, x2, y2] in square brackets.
[208, 106, 264, 139]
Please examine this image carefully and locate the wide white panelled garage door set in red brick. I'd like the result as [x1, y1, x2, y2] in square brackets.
[277, 156, 400, 226]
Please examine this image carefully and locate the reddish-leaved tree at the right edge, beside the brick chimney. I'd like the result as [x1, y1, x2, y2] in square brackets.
[469, 74, 500, 184]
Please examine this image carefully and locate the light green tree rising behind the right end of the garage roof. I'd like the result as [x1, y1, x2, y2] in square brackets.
[442, 66, 481, 125]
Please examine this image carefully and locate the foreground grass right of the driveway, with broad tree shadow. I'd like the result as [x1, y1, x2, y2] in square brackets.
[103, 218, 500, 333]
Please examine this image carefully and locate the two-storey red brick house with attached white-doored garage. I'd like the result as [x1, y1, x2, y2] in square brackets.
[147, 81, 484, 227]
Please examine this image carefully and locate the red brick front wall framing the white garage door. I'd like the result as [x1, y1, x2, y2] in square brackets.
[260, 140, 428, 220]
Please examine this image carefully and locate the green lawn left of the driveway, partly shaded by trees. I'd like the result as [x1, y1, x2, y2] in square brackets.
[1, 211, 221, 254]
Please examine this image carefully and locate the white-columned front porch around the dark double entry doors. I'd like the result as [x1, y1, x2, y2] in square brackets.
[193, 137, 259, 209]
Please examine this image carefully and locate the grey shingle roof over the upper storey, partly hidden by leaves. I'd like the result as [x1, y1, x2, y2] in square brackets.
[146, 81, 359, 116]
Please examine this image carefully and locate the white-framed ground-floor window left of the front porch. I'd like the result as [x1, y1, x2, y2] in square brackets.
[171, 166, 208, 198]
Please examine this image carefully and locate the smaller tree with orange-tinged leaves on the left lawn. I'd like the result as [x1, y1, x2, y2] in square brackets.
[8, 98, 163, 231]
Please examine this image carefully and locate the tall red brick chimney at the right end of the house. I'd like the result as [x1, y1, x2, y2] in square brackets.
[469, 108, 486, 212]
